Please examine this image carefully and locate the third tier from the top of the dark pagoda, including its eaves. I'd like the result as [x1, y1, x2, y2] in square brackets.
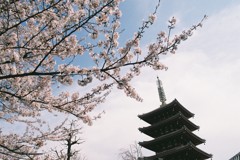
[139, 127, 205, 152]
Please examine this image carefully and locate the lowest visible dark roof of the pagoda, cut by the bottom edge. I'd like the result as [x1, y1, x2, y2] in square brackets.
[144, 143, 212, 160]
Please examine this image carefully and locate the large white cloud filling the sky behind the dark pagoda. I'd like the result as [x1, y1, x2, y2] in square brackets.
[82, 2, 240, 160]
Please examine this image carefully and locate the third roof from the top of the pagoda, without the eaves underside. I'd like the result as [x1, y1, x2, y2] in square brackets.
[139, 126, 205, 152]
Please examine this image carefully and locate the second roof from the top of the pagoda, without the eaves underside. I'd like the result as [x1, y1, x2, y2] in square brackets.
[139, 112, 199, 137]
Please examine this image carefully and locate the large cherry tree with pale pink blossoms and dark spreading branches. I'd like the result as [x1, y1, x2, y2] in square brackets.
[0, 0, 206, 159]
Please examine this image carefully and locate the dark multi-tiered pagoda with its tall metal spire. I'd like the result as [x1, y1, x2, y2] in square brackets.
[138, 79, 212, 160]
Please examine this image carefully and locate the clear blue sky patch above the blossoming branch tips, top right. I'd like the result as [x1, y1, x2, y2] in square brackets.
[121, 0, 239, 43]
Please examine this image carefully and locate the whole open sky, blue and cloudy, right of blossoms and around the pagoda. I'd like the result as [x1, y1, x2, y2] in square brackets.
[80, 0, 240, 160]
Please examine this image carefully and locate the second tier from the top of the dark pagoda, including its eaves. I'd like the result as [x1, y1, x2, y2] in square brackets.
[139, 112, 199, 138]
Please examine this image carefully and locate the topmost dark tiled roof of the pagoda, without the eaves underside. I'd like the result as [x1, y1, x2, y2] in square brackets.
[138, 99, 194, 124]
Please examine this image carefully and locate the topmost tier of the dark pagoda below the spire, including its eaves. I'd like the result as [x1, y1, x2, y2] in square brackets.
[138, 99, 194, 124]
